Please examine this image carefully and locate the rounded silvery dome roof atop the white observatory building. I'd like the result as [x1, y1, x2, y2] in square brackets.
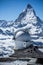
[15, 31, 30, 41]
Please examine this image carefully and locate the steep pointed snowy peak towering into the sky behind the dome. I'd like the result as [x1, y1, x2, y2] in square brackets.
[15, 4, 37, 27]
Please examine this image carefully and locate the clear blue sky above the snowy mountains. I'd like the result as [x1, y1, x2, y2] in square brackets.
[0, 0, 43, 21]
